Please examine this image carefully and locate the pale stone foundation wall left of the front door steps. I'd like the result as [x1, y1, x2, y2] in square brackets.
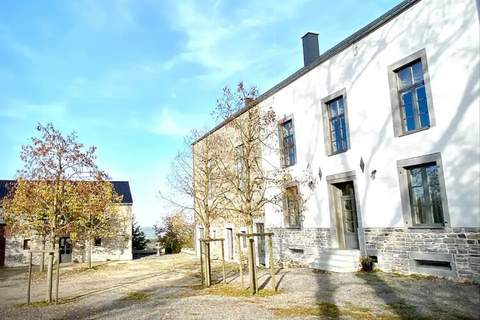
[266, 228, 330, 266]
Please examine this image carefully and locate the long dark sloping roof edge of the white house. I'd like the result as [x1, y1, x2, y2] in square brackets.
[192, 0, 421, 144]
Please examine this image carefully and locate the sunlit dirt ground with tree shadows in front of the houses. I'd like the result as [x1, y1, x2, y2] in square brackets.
[0, 254, 480, 320]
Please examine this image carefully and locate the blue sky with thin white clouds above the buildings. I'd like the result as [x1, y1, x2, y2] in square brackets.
[0, 0, 400, 226]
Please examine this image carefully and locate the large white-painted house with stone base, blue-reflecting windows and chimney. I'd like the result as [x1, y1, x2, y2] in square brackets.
[193, 0, 480, 281]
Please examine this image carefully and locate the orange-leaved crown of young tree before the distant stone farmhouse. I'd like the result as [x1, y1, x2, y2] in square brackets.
[3, 124, 120, 266]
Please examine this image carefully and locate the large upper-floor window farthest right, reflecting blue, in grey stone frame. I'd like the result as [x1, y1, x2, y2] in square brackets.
[389, 50, 434, 136]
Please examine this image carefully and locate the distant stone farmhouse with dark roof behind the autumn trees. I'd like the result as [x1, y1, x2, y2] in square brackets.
[0, 180, 133, 267]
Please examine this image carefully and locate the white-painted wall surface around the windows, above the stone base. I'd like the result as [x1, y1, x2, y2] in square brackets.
[261, 0, 480, 227]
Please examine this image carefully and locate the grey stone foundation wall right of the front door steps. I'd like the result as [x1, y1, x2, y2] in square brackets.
[364, 228, 480, 282]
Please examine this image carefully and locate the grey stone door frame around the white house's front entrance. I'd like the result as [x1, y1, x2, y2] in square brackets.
[326, 170, 365, 252]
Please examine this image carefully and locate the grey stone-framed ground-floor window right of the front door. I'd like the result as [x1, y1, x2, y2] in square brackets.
[398, 154, 447, 228]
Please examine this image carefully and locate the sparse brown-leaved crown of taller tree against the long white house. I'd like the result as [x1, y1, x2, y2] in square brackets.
[214, 83, 287, 233]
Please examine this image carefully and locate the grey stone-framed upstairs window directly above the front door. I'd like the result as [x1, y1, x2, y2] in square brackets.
[322, 89, 349, 155]
